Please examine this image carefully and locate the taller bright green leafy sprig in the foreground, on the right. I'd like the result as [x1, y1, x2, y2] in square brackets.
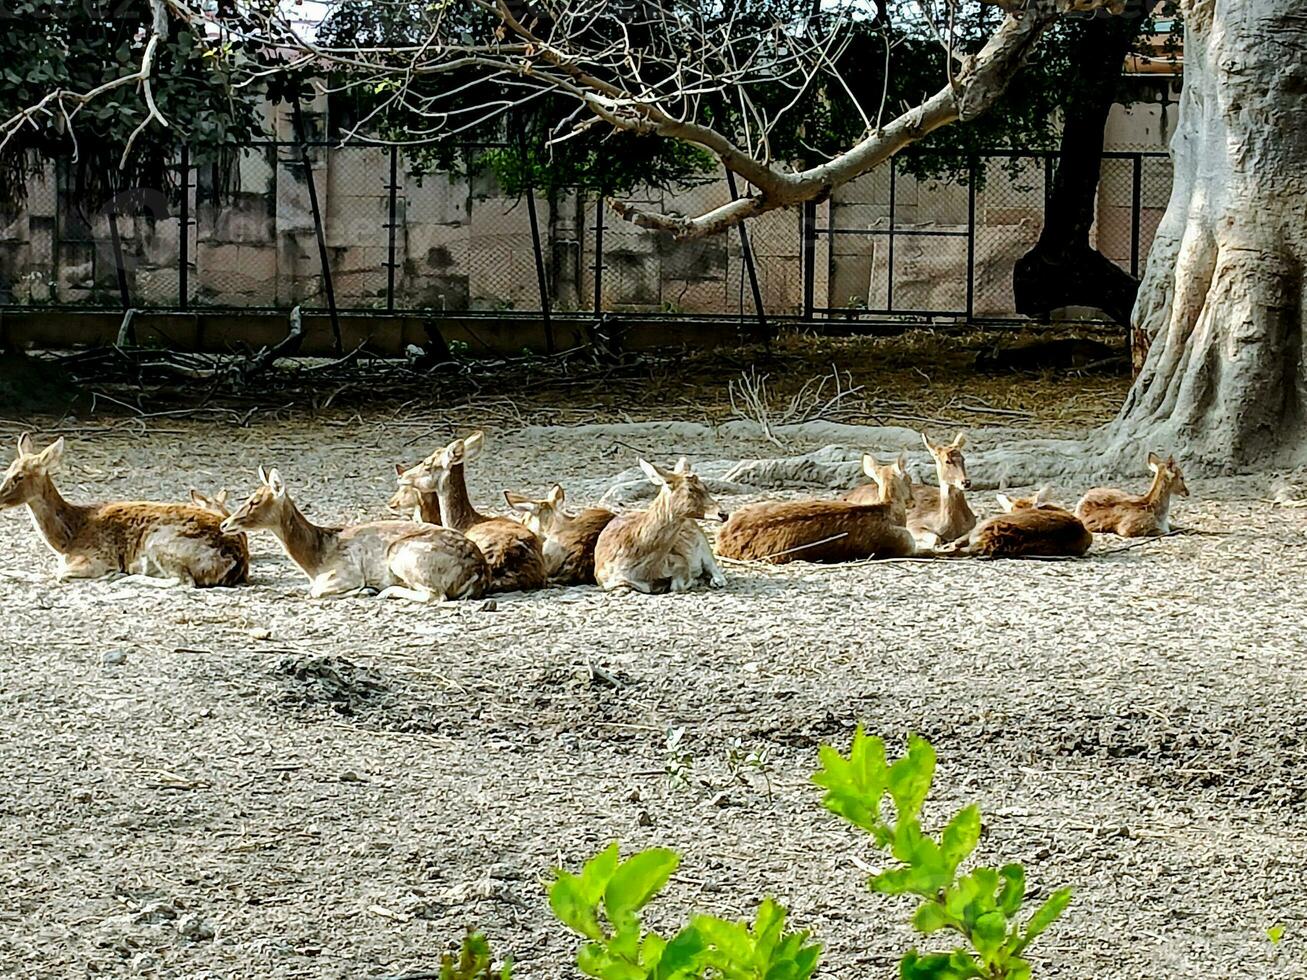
[813, 725, 1070, 980]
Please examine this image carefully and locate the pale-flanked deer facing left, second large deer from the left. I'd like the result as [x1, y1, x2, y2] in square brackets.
[222, 466, 490, 602]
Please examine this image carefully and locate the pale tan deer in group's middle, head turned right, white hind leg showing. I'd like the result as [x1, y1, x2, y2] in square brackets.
[595, 456, 727, 595]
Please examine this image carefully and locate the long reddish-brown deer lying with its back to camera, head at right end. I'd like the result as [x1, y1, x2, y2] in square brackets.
[718, 455, 918, 564]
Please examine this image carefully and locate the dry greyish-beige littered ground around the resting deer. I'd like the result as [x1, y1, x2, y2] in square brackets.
[0, 416, 1307, 980]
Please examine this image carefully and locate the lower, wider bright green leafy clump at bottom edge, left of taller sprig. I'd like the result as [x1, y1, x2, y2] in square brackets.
[549, 843, 821, 980]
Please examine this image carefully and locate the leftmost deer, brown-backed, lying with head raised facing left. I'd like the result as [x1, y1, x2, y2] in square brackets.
[0, 434, 250, 588]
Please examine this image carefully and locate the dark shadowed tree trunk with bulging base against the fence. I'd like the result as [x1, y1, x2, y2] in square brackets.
[1012, 5, 1142, 327]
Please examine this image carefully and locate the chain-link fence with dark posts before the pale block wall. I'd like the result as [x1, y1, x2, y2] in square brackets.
[0, 141, 1171, 330]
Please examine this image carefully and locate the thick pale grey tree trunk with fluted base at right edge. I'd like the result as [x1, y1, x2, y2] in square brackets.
[1102, 0, 1307, 472]
